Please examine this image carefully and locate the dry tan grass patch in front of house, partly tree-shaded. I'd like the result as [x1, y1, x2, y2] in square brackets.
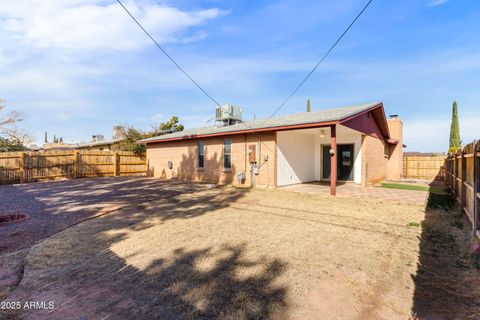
[0, 188, 476, 319]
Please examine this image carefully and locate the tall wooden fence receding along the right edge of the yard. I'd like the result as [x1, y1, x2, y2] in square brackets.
[445, 141, 480, 237]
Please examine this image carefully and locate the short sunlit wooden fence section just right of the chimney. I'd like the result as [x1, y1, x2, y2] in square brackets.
[402, 156, 445, 180]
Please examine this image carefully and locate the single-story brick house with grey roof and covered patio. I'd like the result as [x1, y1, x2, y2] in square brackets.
[140, 102, 403, 195]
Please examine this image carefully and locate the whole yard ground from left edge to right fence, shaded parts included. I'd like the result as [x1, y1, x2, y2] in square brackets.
[0, 179, 480, 319]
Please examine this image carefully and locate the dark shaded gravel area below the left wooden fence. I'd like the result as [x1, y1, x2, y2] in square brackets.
[0, 177, 219, 253]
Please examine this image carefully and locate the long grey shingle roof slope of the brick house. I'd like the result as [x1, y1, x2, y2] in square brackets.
[139, 102, 381, 143]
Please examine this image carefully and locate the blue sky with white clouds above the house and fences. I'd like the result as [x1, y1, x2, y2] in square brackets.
[0, 0, 480, 151]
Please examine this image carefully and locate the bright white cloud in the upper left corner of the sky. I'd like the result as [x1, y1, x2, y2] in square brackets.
[0, 0, 226, 50]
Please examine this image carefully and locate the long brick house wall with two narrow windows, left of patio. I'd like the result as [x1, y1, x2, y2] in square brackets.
[147, 132, 276, 186]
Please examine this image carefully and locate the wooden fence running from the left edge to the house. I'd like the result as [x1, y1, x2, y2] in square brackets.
[0, 150, 147, 184]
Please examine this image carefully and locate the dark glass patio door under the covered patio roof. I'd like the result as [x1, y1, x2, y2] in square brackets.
[322, 144, 354, 180]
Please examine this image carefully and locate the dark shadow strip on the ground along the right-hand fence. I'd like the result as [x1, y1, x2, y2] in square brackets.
[412, 180, 480, 320]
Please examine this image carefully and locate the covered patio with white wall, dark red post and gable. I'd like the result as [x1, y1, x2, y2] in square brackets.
[277, 104, 399, 196]
